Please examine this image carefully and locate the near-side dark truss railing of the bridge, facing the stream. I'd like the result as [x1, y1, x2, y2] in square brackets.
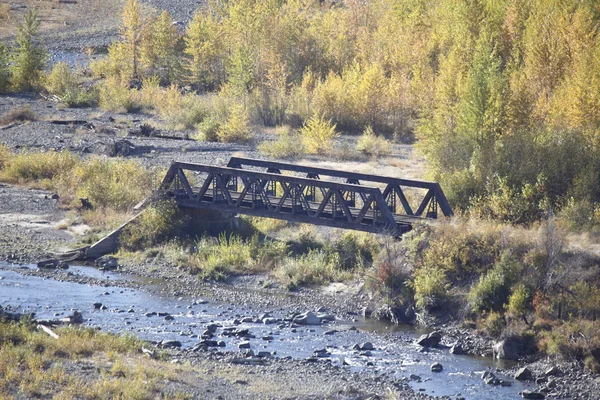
[160, 162, 411, 235]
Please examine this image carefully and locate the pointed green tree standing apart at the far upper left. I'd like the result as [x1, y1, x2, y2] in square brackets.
[11, 8, 48, 91]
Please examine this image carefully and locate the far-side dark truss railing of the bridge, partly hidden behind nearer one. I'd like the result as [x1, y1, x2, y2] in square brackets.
[227, 157, 454, 218]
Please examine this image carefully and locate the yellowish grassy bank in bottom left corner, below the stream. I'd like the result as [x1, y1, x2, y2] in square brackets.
[0, 320, 189, 399]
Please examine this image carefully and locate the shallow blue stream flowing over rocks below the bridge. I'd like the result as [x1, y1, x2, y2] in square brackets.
[0, 264, 528, 400]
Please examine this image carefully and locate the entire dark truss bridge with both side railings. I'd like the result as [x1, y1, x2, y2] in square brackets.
[160, 157, 453, 236]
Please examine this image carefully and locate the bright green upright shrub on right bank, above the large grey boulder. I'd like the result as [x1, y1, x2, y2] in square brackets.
[468, 252, 522, 312]
